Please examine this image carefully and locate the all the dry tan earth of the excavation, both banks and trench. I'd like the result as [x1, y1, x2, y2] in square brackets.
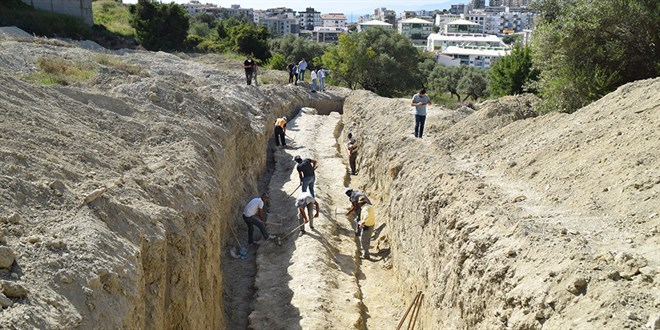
[0, 28, 660, 329]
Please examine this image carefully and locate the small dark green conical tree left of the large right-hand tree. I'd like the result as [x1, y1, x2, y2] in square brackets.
[488, 44, 538, 97]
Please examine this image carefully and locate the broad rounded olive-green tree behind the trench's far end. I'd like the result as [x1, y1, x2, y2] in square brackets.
[322, 28, 421, 96]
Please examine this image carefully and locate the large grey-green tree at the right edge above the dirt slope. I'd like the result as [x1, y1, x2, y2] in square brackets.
[532, 0, 660, 112]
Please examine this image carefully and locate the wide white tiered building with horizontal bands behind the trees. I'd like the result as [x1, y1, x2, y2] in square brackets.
[426, 20, 509, 68]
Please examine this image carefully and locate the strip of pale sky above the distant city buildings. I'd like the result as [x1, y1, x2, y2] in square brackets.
[123, 0, 456, 21]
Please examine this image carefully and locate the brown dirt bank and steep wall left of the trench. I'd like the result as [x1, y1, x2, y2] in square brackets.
[0, 40, 341, 329]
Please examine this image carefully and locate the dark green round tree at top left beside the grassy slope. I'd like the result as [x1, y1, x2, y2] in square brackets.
[130, 0, 189, 50]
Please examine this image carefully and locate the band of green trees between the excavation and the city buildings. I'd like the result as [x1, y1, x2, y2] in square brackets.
[130, 0, 660, 112]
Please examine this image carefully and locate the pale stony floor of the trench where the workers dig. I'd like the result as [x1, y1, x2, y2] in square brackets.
[223, 108, 407, 329]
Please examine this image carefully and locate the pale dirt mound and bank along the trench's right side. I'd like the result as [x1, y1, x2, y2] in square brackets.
[344, 79, 660, 329]
